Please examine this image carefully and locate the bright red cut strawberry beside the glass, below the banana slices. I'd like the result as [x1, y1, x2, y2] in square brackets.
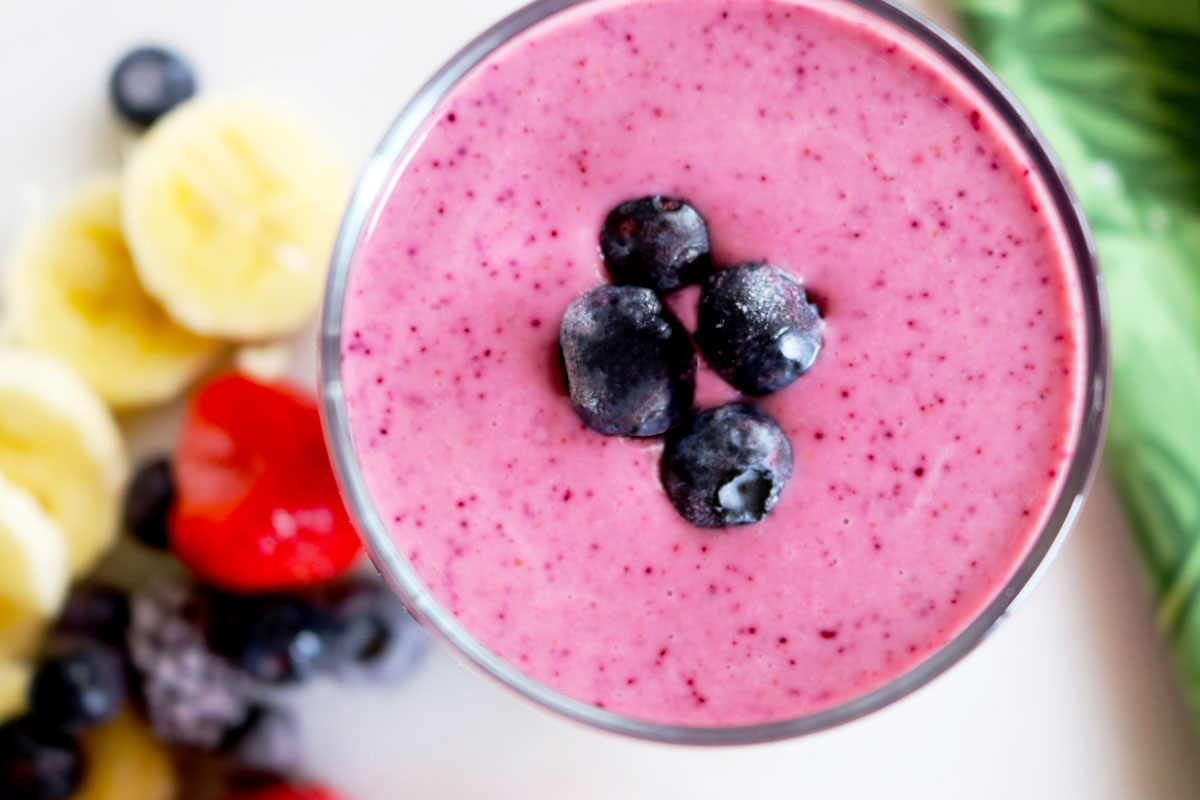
[170, 374, 360, 591]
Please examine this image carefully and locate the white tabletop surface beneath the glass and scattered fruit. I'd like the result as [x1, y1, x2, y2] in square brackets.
[0, 0, 1200, 800]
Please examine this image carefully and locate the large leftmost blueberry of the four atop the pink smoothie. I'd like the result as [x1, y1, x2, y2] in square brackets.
[558, 285, 696, 437]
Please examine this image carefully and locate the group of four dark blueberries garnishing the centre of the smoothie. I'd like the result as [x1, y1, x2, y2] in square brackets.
[559, 196, 822, 528]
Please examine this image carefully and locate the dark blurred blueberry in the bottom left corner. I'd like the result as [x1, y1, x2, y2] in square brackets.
[0, 716, 84, 800]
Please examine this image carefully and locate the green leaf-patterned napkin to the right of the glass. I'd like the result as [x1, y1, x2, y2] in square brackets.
[952, 0, 1200, 730]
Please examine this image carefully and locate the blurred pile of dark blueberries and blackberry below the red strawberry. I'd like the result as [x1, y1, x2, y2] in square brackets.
[0, 579, 428, 800]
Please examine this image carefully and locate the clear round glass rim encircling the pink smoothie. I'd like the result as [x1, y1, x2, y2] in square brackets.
[319, 0, 1110, 745]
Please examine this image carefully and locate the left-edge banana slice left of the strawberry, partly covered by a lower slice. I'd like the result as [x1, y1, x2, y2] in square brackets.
[0, 349, 128, 575]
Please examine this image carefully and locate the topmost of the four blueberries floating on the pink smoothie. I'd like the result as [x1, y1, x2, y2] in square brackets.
[600, 194, 713, 294]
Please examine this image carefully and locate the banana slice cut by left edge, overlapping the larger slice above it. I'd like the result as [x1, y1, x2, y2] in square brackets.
[0, 475, 71, 657]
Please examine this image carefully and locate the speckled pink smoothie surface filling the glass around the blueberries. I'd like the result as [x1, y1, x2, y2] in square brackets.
[342, 0, 1085, 726]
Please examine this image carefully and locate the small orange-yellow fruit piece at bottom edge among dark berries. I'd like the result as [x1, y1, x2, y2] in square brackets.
[71, 711, 179, 800]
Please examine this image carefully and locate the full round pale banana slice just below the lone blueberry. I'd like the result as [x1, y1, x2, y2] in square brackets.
[121, 95, 347, 339]
